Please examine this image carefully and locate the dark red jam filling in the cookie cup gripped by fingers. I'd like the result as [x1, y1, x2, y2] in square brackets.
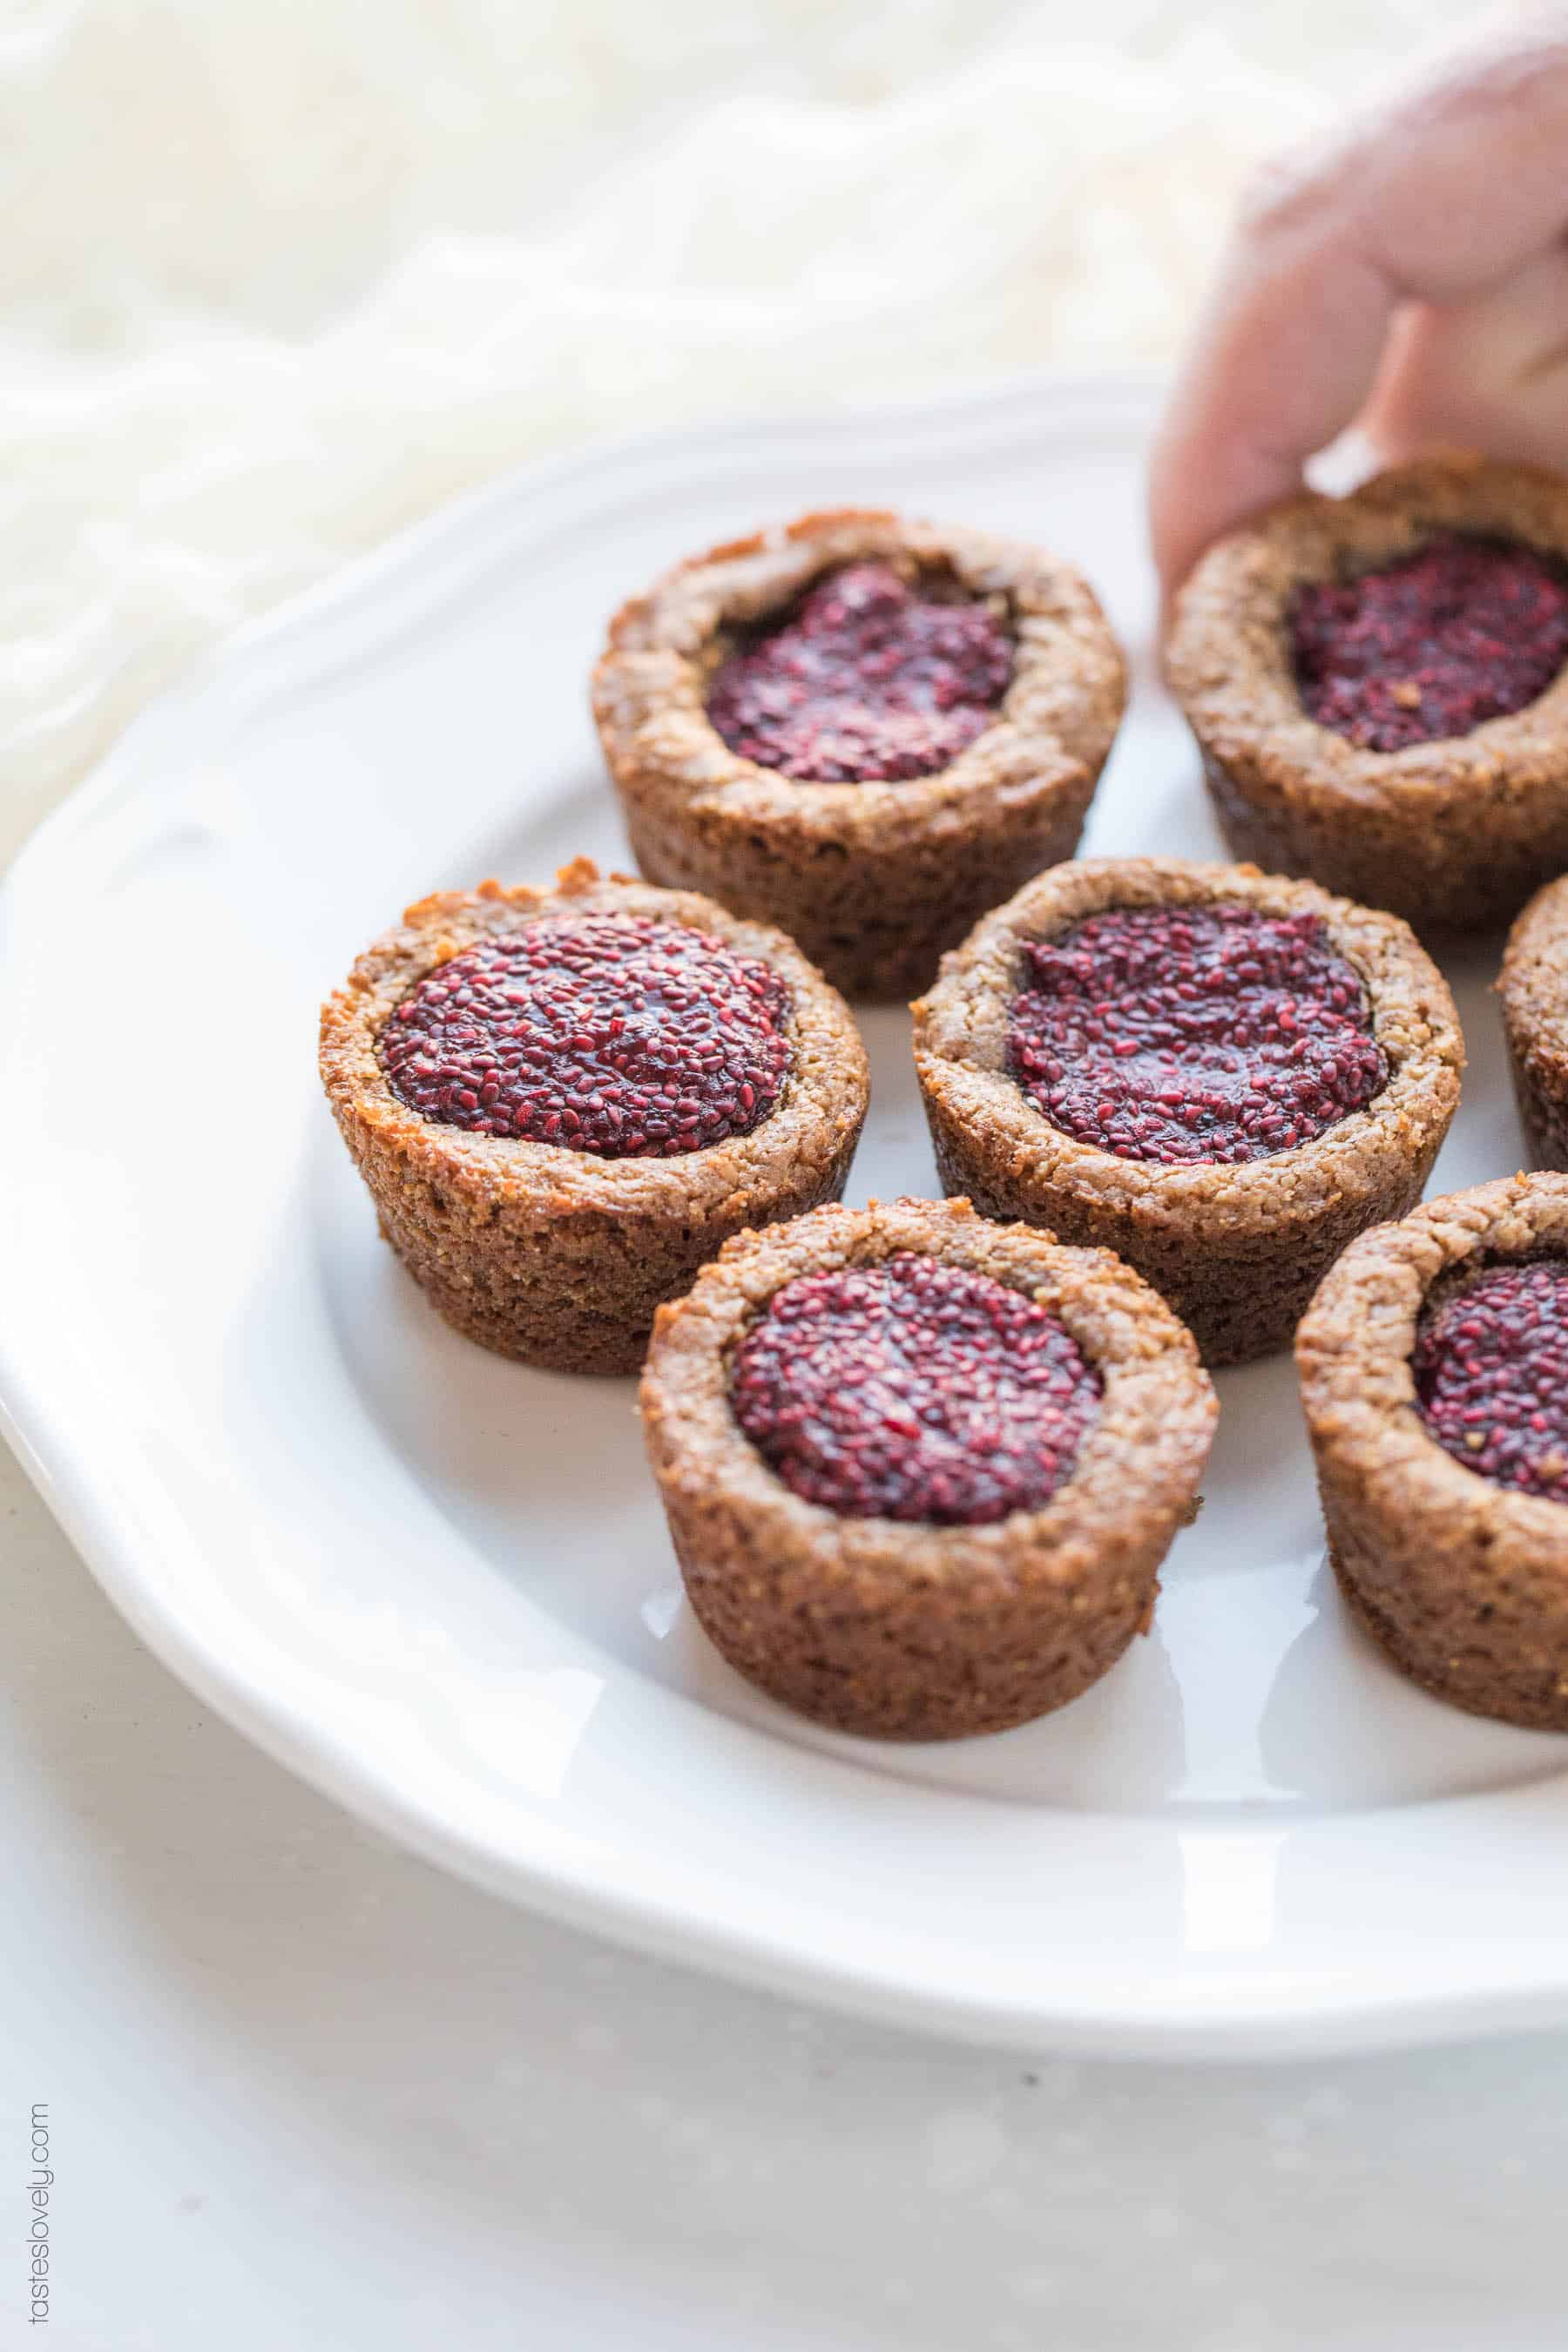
[1291, 531, 1568, 750]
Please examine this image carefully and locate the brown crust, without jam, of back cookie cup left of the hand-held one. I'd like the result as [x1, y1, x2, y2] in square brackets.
[592, 508, 1126, 1000]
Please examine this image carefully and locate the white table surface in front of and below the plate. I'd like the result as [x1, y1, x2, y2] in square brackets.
[0, 1456, 1568, 2352]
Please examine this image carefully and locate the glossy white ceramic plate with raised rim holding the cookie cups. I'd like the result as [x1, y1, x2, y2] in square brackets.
[0, 379, 1568, 2053]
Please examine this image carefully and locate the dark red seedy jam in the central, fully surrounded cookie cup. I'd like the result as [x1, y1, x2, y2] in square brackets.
[1009, 906, 1389, 1165]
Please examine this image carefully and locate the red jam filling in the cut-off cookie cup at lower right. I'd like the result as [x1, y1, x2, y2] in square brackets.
[1413, 1259, 1568, 1503]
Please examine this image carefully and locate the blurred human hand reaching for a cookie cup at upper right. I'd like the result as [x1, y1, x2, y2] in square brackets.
[1150, 4, 1568, 595]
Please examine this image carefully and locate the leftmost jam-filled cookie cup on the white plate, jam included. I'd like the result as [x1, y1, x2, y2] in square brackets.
[320, 859, 868, 1374]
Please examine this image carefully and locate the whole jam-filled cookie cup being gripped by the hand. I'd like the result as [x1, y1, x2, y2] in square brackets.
[1166, 456, 1568, 934]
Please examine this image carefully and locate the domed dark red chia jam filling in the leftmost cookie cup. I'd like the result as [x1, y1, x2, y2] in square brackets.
[381, 915, 790, 1159]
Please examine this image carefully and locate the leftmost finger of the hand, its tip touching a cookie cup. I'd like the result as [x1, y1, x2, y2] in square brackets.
[1150, 23, 1568, 591]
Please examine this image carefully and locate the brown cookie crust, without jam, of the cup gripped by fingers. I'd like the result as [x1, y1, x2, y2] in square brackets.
[1166, 456, 1568, 934]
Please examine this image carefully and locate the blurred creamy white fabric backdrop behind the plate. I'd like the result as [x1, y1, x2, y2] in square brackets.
[0, 0, 1471, 856]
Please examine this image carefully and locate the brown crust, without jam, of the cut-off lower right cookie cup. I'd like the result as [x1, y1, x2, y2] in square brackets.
[1295, 1173, 1568, 1731]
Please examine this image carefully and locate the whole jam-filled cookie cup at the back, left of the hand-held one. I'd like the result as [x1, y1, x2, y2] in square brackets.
[592, 510, 1126, 1000]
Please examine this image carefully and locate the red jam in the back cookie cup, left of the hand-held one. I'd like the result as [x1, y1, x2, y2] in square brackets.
[707, 562, 1013, 783]
